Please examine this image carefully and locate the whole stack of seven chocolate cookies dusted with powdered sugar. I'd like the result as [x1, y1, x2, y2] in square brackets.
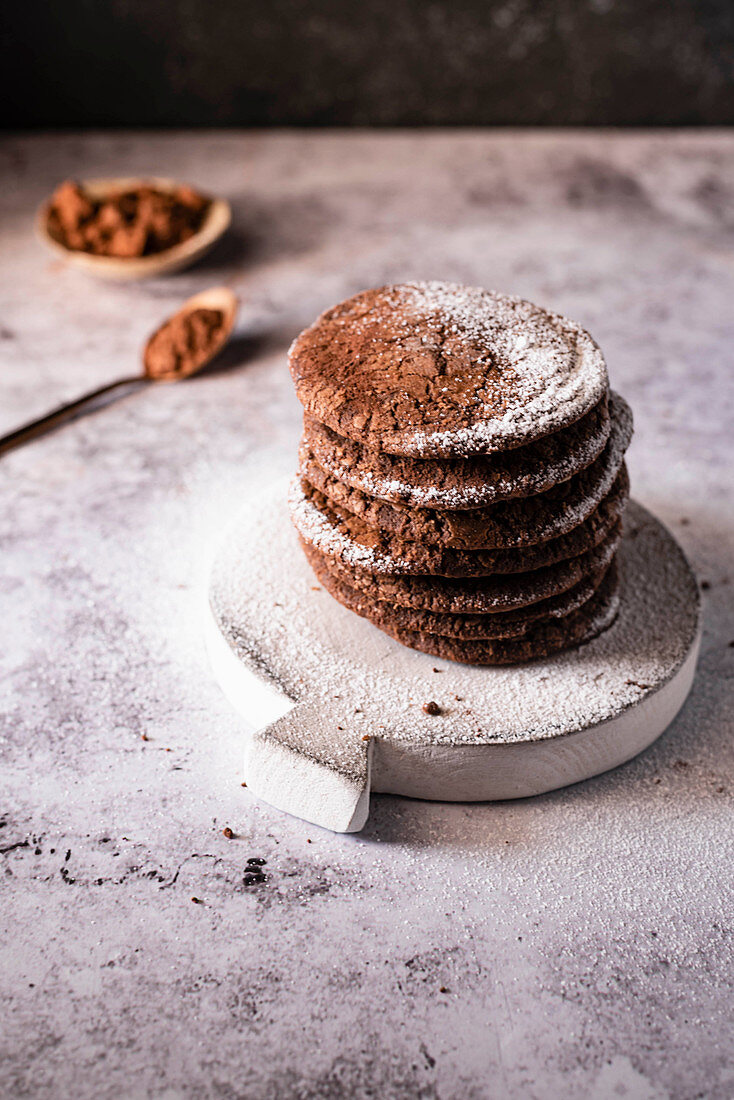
[289, 283, 632, 664]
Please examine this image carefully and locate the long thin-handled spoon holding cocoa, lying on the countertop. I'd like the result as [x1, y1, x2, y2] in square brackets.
[0, 286, 238, 454]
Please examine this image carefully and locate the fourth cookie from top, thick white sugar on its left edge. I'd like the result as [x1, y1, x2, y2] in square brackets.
[289, 469, 629, 576]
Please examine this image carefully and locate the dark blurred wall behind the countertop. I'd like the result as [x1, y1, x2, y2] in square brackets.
[0, 0, 734, 128]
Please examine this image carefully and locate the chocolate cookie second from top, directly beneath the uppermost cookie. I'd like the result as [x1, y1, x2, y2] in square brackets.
[304, 397, 610, 509]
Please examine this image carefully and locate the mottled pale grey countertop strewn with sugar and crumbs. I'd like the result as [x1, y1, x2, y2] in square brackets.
[0, 132, 734, 1100]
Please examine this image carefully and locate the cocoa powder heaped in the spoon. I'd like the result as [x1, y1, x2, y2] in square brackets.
[143, 308, 227, 382]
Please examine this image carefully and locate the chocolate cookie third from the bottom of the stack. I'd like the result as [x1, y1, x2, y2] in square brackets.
[300, 524, 622, 615]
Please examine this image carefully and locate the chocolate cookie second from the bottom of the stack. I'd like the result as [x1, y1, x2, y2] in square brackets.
[309, 543, 616, 641]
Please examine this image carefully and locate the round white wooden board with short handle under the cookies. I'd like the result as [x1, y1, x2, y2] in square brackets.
[206, 484, 700, 832]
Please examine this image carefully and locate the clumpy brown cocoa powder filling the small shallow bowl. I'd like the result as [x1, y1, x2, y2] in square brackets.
[46, 180, 211, 259]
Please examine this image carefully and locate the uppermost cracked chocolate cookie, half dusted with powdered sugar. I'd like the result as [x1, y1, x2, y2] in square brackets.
[288, 283, 607, 458]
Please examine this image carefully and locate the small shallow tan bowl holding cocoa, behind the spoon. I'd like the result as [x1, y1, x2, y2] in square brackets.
[35, 176, 232, 279]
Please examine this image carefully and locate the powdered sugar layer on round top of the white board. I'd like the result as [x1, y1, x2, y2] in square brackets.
[210, 485, 699, 756]
